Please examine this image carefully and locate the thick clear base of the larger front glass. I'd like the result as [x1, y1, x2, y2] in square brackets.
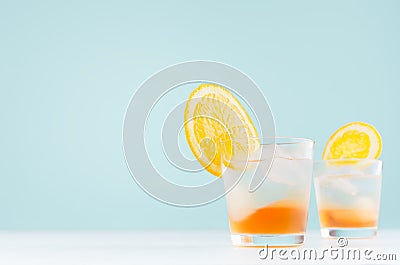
[231, 234, 304, 247]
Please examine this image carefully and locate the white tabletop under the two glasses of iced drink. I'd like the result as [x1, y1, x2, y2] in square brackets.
[0, 230, 400, 265]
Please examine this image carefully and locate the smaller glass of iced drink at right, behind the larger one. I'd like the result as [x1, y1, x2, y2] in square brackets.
[314, 159, 382, 238]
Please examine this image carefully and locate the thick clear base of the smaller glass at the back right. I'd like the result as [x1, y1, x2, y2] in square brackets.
[321, 227, 378, 238]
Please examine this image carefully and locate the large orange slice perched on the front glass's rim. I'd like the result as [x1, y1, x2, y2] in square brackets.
[184, 84, 259, 177]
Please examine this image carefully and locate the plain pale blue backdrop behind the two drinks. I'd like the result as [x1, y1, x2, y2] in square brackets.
[0, 1, 400, 229]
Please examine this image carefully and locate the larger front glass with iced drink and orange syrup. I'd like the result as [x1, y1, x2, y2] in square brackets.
[222, 137, 314, 246]
